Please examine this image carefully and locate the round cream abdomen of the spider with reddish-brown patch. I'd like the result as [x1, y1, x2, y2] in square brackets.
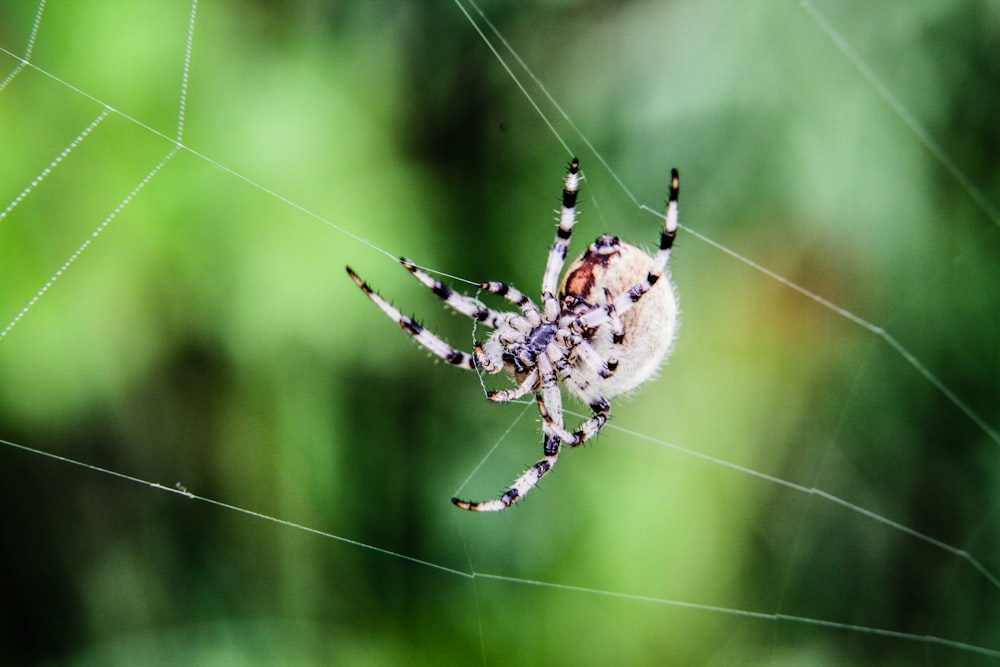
[559, 234, 677, 398]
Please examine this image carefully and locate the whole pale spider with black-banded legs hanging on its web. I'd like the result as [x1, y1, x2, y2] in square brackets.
[347, 158, 680, 512]
